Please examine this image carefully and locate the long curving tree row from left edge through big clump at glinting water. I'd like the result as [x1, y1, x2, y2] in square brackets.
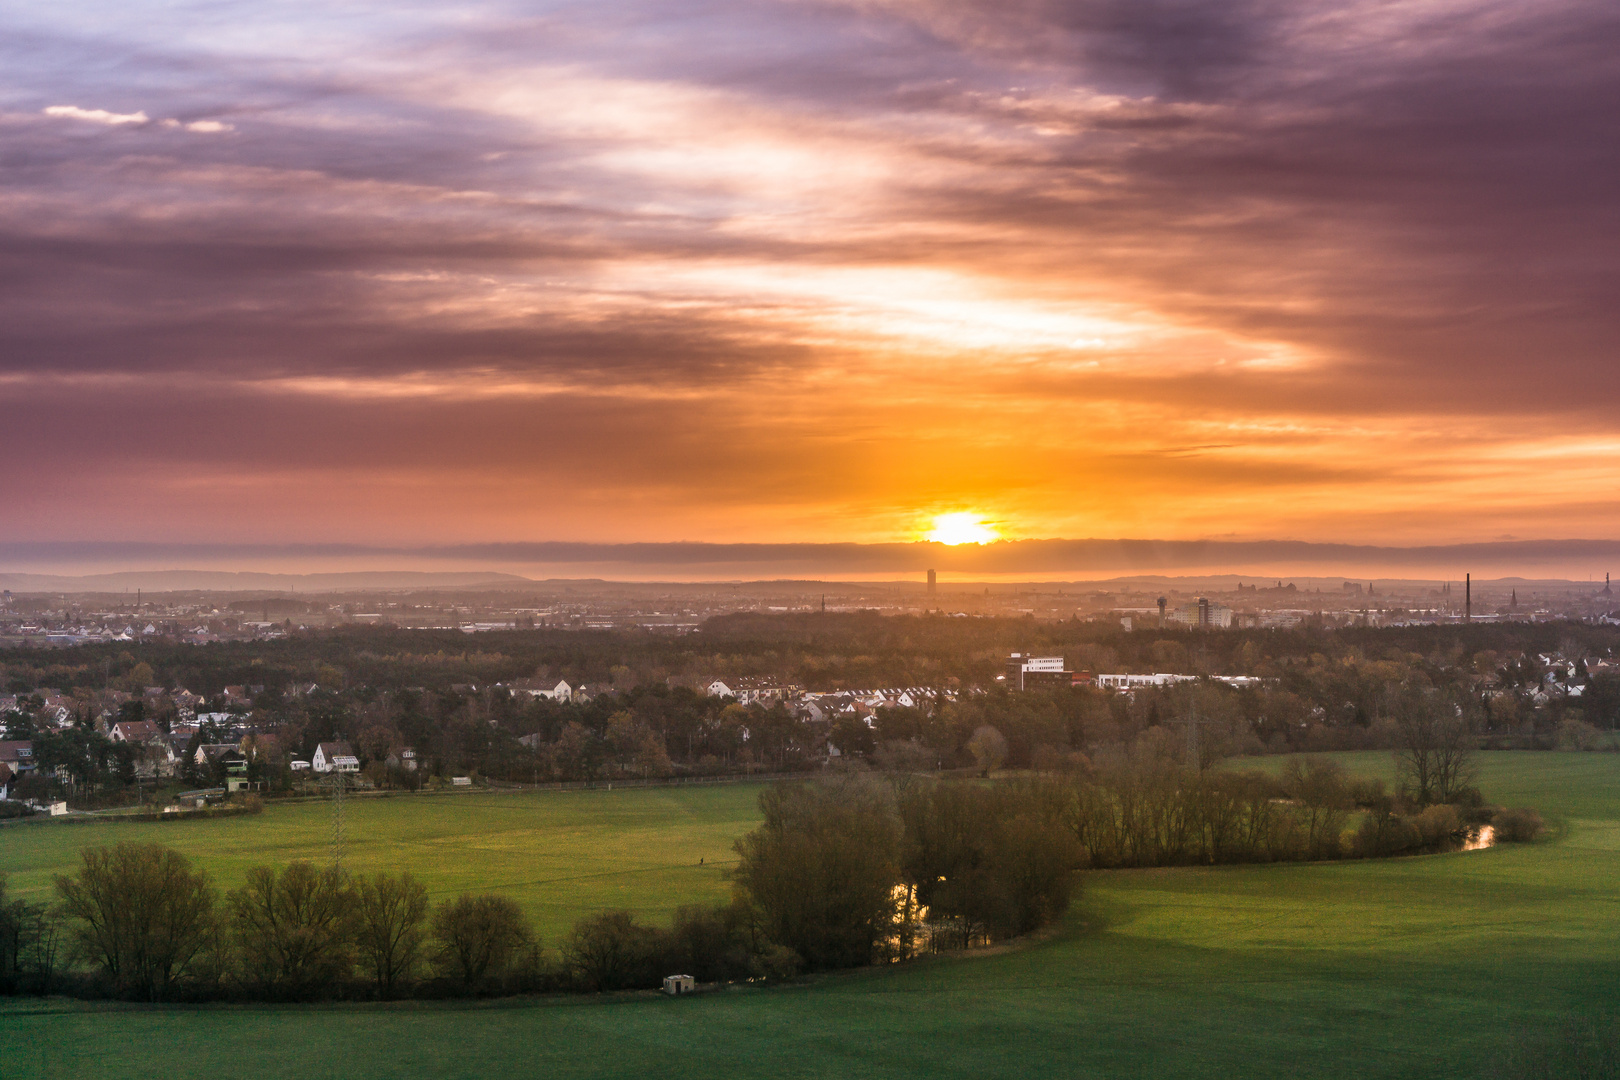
[22, 776, 1084, 1001]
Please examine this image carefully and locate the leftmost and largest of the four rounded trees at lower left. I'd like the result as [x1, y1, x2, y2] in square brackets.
[55, 842, 215, 1001]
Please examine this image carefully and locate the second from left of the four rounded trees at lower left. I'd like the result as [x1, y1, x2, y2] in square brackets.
[225, 861, 356, 997]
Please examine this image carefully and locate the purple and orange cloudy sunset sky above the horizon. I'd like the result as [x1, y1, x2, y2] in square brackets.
[0, 0, 1620, 576]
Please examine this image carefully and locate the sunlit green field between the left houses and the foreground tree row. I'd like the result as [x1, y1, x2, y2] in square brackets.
[0, 784, 760, 939]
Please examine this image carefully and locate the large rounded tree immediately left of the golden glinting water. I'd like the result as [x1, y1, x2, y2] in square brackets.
[735, 777, 901, 968]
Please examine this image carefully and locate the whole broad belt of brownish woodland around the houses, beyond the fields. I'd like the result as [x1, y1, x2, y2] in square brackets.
[0, 614, 1620, 798]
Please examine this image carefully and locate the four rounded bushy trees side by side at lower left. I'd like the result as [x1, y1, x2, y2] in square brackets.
[55, 844, 536, 1001]
